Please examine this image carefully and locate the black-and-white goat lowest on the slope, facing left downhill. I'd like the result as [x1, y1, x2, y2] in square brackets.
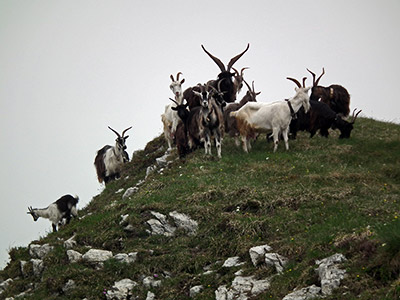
[27, 195, 79, 232]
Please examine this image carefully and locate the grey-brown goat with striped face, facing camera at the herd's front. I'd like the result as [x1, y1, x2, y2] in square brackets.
[186, 85, 224, 158]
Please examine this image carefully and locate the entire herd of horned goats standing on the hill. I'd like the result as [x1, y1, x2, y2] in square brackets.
[28, 44, 361, 231]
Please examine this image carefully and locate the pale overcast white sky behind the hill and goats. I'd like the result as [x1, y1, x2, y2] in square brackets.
[0, 0, 400, 267]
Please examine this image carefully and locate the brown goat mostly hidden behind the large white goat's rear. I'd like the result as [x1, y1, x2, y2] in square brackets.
[224, 79, 261, 146]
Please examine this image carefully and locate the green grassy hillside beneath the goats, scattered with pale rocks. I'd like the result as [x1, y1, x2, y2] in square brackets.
[0, 118, 400, 300]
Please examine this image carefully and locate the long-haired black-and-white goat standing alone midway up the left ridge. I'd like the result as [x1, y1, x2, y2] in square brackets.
[94, 126, 132, 184]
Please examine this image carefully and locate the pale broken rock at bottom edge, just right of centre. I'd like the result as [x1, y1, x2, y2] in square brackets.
[215, 276, 270, 300]
